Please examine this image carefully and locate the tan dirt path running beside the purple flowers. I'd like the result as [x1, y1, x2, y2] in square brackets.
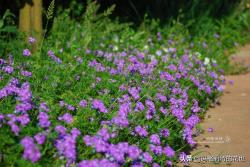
[190, 45, 250, 167]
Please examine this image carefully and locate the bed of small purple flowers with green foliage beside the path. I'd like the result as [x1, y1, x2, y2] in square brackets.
[0, 33, 224, 167]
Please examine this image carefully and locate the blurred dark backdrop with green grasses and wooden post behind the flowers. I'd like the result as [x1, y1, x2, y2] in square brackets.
[0, 0, 250, 69]
